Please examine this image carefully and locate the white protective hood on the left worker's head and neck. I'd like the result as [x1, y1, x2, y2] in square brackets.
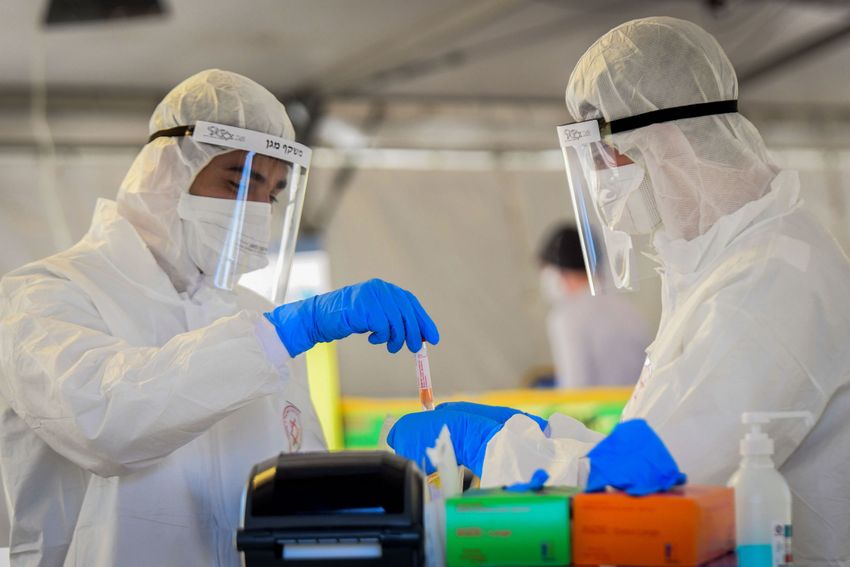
[116, 69, 295, 292]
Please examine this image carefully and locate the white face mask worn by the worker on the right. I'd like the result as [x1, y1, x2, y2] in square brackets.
[597, 163, 661, 234]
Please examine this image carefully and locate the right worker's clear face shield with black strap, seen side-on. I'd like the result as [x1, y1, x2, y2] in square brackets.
[557, 101, 737, 295]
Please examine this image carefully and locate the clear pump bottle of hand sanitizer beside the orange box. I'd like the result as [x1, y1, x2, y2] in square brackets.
[728, 411, 812, 567]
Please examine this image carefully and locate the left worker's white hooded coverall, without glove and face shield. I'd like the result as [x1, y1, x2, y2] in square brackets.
[0, 70, 324, 567]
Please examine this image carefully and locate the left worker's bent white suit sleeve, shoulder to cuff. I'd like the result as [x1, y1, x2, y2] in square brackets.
[0, 270, 284, 476]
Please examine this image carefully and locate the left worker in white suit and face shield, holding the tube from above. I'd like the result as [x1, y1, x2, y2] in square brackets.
[0, 70, 439, 567]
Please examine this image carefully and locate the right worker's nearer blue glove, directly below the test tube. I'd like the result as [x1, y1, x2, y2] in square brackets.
[387, 409, 503, 477]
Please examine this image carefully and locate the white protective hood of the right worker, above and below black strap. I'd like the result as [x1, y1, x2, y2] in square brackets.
[566, 17, 779, 240]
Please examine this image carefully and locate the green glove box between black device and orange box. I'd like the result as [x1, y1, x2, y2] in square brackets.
[446, 487, 578, 567]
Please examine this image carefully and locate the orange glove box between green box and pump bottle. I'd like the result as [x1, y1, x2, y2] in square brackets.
[572, 485, 735, 566]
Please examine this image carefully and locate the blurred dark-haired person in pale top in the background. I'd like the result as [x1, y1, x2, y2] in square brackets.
[539, 225, 650, 388]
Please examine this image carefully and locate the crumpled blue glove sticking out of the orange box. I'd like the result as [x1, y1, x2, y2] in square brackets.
[587, 419, 687, 496]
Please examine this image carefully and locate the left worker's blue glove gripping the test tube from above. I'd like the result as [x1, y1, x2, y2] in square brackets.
[264, 279, 440, 357]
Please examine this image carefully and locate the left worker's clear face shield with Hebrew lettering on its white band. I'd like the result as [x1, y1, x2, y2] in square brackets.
[151, 121, 311, 303]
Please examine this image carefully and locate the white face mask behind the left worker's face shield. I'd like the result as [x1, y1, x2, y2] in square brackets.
[177, 193, 272, 275]
